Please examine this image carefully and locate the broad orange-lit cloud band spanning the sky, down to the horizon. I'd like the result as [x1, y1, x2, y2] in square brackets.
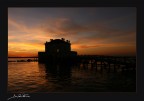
[8, 17, 136, 55]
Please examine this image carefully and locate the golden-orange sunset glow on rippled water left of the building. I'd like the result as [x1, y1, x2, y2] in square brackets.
[8, 62, 47, 92]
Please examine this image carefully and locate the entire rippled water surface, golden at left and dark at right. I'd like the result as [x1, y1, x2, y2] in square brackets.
[8, 58, 136, 93]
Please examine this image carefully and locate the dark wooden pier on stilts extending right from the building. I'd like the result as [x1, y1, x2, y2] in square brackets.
[77, 55, 136, 71]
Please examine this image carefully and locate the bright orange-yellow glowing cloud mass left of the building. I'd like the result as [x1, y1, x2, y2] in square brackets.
[8, 18, 55, 56]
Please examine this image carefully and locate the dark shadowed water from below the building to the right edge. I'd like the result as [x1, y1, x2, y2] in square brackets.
[36, 64, 136, 92]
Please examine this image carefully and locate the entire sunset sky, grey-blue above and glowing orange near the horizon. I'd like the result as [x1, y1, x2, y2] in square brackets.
[8, 7, 136, 57]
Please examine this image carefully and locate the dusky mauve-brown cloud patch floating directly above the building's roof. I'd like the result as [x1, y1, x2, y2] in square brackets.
[41, 18, 87, 36]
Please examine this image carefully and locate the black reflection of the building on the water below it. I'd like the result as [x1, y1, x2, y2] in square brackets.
[45, 64, 71, 86]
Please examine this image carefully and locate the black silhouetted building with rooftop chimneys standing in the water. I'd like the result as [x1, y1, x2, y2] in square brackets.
[38, 38, 77, 62]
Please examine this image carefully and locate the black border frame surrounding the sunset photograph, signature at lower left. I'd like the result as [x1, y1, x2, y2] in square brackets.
[0, 0, 144, 101]
